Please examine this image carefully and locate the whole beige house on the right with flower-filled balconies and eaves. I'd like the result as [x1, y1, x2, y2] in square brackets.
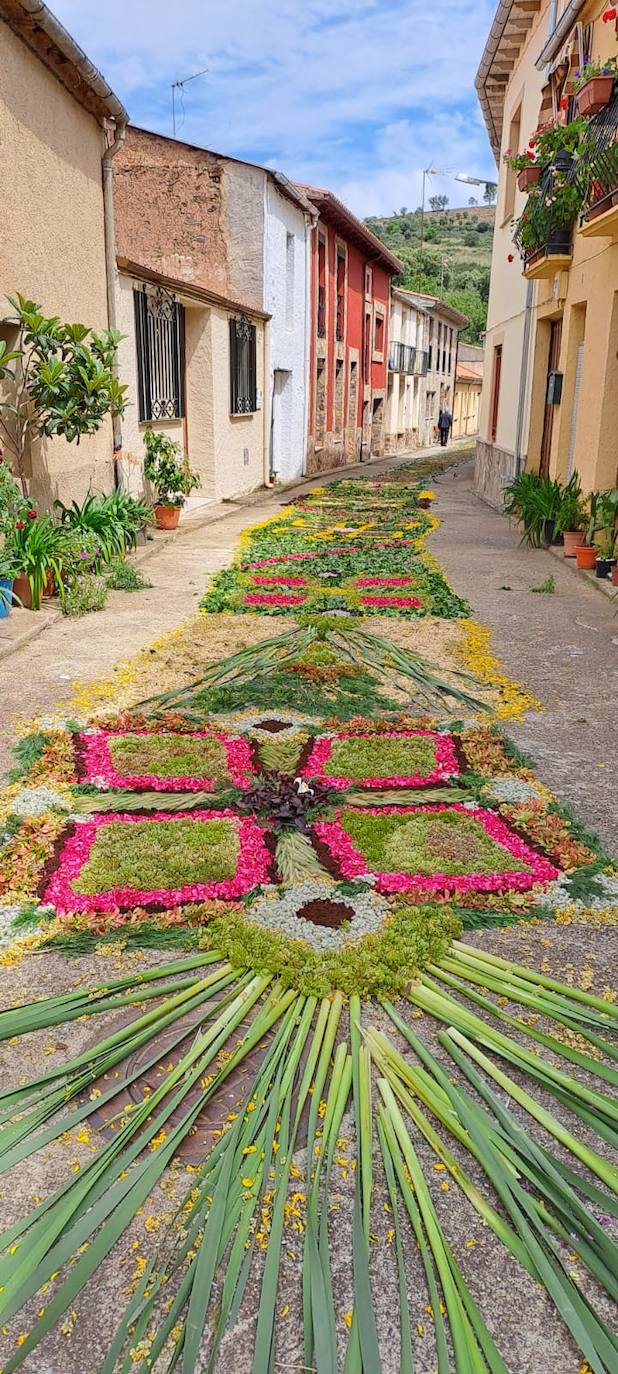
[475, 0, 618, 507]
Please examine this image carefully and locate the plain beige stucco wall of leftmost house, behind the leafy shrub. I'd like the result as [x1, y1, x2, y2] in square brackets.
[0, 21, 113, 504]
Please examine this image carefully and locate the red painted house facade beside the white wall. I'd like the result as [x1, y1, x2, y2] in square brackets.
[296, 187, 402, 474]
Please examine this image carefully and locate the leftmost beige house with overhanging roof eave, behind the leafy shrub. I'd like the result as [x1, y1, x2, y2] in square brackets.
[0, 0, 128, 507]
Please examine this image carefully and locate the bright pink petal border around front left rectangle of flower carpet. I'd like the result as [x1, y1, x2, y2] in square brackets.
[43, 811, 271, 912]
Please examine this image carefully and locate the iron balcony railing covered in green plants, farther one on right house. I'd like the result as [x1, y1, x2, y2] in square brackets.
[514, 153, 581, 267]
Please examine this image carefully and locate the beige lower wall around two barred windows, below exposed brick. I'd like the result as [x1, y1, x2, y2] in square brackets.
[117, 273, 264, 500]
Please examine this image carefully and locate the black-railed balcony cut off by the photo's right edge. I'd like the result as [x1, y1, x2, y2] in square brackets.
[580, 95, 618, 239]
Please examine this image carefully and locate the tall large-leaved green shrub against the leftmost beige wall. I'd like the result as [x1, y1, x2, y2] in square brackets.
[0, 293, 128, 481]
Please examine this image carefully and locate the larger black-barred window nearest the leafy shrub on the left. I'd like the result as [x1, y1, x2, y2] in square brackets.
[133, 287, 184, 422]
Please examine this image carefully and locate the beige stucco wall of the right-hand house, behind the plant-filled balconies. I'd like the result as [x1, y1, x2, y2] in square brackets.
[477, 3, 618, 491]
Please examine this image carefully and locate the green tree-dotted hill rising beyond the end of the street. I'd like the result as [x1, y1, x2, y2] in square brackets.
[365, 205, 496, 344]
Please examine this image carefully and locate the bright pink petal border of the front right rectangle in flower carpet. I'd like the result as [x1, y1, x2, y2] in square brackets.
[313, 802, 559, 893]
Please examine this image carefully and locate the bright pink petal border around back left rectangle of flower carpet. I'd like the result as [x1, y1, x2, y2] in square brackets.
[80, 730, 255, 791]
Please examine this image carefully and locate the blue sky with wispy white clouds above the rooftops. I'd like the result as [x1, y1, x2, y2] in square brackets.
[51, 0, 497, 217]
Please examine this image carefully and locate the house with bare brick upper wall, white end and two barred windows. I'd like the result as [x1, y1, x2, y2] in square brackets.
[114, 126, 313, 500]
